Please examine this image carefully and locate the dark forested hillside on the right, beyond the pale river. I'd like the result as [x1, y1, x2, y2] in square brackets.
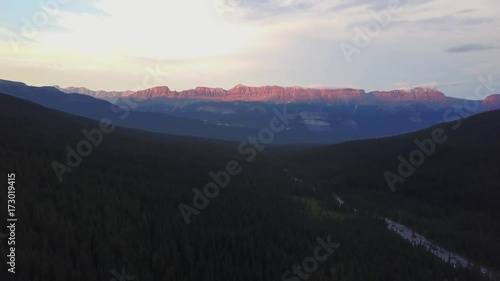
[293, 108, 500, 270]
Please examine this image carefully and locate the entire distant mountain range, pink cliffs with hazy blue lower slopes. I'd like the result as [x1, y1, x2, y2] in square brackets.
[4, 81, 500, 144]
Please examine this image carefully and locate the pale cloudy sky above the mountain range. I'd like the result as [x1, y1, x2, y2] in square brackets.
[0, 0, 500, 98]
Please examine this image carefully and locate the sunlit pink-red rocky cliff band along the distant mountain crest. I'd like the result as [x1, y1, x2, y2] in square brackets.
[57, 85, 454, 103]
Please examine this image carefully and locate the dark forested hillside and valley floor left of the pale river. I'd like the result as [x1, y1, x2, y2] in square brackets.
[0, 92, 495, 281]
